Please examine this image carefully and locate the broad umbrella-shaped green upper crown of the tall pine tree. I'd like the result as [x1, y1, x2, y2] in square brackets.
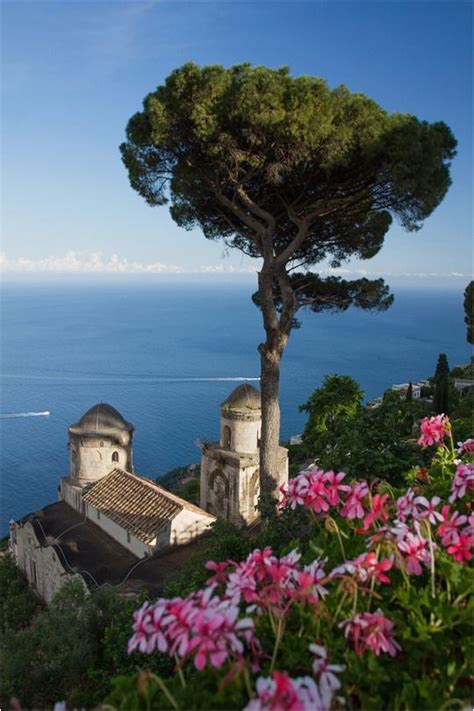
[121, 63, 456, 266]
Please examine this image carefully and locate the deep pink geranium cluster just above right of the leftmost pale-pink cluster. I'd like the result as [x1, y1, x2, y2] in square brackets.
[206, 548, 327, 615]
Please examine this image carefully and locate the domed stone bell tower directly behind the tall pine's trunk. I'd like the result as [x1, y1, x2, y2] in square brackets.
[201, 384, 288, 526]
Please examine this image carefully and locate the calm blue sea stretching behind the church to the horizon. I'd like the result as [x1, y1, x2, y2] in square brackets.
[0, 283, 470, 531]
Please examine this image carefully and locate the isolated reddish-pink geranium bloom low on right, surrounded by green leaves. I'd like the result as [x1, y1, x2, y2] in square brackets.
[339, 610, 401, 657]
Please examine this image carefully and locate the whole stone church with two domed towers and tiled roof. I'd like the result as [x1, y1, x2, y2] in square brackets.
[10, 384, 288, 602]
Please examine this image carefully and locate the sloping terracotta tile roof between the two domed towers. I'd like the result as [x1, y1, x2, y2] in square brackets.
[83, 469, 186, 543]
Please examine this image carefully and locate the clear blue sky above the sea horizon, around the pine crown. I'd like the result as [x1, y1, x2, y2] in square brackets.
[2, 0, 472, 286]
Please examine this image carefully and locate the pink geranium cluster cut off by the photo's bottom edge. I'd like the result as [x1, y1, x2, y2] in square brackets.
[244, 671, 329, 711]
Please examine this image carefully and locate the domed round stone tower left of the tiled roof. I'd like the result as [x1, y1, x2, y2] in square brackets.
[69, 403, 134, 487]
